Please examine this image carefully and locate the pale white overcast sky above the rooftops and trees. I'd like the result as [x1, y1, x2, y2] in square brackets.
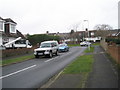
[0, 0, 119, 34]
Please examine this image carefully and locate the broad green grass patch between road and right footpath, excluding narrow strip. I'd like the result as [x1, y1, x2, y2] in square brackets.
[63, 55, 93, 74]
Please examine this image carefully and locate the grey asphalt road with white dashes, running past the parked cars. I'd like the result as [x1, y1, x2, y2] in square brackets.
[0, 47, 86, 88]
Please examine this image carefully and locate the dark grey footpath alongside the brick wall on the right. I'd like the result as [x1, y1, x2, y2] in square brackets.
[86, 46, 118, 88]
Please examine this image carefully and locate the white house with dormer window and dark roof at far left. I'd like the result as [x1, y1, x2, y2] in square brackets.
[0, 17, 31, 49]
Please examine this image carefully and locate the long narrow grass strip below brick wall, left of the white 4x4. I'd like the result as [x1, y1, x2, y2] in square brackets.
[0, 55, 34, 66]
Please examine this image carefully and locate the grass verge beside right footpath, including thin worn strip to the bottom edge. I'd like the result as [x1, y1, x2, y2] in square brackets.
[62, 55, 94, 88]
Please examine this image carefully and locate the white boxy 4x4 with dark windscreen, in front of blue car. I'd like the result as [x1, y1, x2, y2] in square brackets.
[34, 41, 58, 58]
